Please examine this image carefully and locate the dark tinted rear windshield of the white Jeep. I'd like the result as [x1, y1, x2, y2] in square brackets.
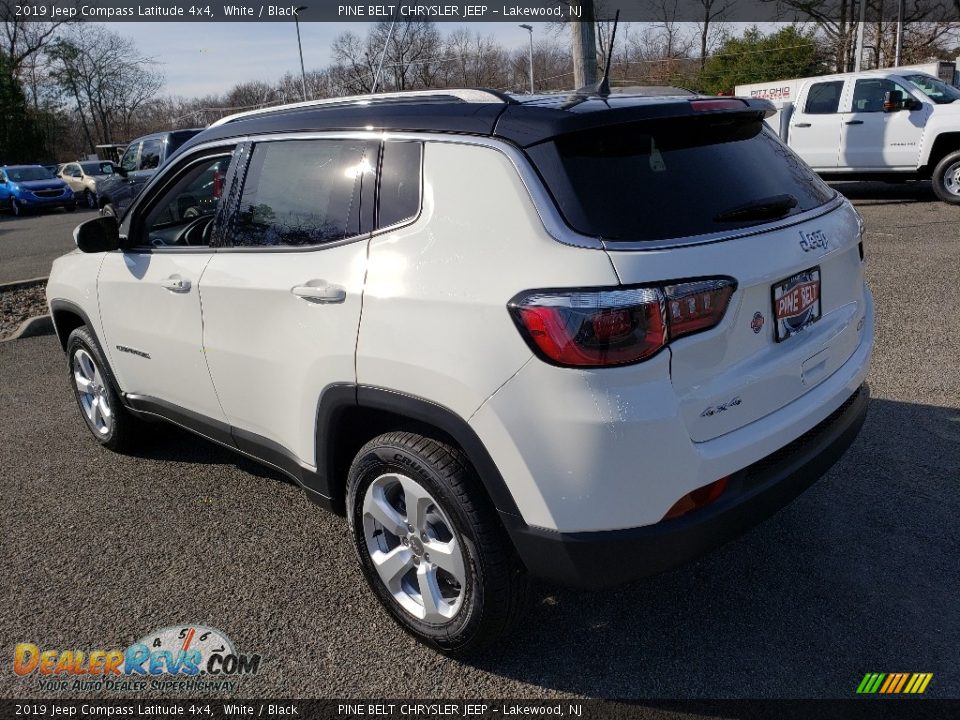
[528, 116, 835, 241]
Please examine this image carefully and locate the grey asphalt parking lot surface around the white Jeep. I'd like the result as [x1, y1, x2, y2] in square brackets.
[0, 185, 960, 699]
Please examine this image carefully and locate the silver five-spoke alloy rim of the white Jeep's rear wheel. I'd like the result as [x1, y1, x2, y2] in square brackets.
[363, 473, 467, 625]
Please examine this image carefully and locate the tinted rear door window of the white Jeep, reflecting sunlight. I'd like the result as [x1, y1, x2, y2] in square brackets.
[230, 140, 377, 247]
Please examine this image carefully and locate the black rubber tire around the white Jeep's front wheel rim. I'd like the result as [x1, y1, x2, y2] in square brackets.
[67, 325, 142, 452]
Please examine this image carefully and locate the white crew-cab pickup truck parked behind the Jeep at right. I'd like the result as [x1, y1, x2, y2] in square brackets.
[735, 68, 960, 205]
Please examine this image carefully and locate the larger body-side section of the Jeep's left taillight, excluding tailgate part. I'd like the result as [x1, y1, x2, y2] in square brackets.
[510, 288, 667, 367]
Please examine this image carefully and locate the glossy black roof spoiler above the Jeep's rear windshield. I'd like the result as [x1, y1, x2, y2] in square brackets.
[493, 95, 777, 147]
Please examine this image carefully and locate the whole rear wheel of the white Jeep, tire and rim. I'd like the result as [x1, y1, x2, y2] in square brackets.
[347, 432, 528, 654]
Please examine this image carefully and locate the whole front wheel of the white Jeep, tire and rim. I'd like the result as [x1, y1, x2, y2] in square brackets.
[67, 326, 141, 452]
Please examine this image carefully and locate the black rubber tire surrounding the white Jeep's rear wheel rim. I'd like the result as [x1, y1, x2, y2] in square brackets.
[347, 431, 529, 655]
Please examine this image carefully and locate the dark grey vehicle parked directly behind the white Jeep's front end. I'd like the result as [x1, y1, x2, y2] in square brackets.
[97, 128, 200, 217]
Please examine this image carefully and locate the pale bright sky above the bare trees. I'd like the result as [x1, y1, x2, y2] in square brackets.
[125, 22, 556, 97]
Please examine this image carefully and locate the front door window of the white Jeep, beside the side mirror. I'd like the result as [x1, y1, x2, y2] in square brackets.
[138, 154, 233, 247]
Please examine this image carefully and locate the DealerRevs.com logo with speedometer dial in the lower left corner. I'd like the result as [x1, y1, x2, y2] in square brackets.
[13, 624, 260, 692]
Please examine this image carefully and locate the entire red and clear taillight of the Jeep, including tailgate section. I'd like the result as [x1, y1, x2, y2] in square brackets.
[509, 278, 736, 367]
